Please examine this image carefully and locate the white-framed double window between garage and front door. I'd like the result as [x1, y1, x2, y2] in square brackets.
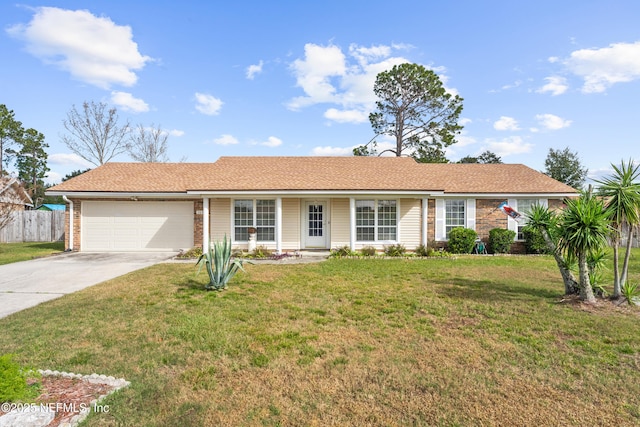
[233, 199, 276, 242]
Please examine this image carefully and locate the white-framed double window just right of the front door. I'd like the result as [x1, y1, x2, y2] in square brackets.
[356, 200, 398, 242]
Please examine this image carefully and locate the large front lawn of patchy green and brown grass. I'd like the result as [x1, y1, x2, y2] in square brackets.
[0, 251, 640, 426]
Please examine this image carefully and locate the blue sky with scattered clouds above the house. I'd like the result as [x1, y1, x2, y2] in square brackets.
[0, 0, 640, 183]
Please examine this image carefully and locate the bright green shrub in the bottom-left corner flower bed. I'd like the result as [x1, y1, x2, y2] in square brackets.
[0, 354, 40, 402]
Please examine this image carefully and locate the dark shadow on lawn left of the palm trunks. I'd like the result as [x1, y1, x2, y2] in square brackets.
[434, 278, 562, 302]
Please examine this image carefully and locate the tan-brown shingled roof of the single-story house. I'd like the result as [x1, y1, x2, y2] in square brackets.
[49, 157, 576, 194]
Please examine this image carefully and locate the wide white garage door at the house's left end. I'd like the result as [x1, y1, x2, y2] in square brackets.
[81, 201, 193, 251]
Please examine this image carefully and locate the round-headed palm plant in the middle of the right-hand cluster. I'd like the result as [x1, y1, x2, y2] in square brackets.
[558, 189, 610, 303]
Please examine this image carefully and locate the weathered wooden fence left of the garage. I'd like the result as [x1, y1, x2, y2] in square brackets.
[0, 211, 65, 243]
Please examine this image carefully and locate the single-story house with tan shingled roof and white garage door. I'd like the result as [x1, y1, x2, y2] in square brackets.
[47, 157, 577, 251]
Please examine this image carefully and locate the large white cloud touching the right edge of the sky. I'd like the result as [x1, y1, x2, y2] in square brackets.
[565, 41, 640, 93]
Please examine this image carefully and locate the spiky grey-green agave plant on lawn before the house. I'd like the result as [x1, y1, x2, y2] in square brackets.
[196, 235, 250, 291]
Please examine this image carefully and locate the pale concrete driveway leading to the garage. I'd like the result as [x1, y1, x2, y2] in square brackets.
[0, 252, 176, 318]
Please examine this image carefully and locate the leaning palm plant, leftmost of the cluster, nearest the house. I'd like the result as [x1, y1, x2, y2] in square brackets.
[526, 204, 580, 295]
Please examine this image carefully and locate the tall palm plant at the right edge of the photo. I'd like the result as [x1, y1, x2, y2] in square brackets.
[596, 160, 640, 298]
